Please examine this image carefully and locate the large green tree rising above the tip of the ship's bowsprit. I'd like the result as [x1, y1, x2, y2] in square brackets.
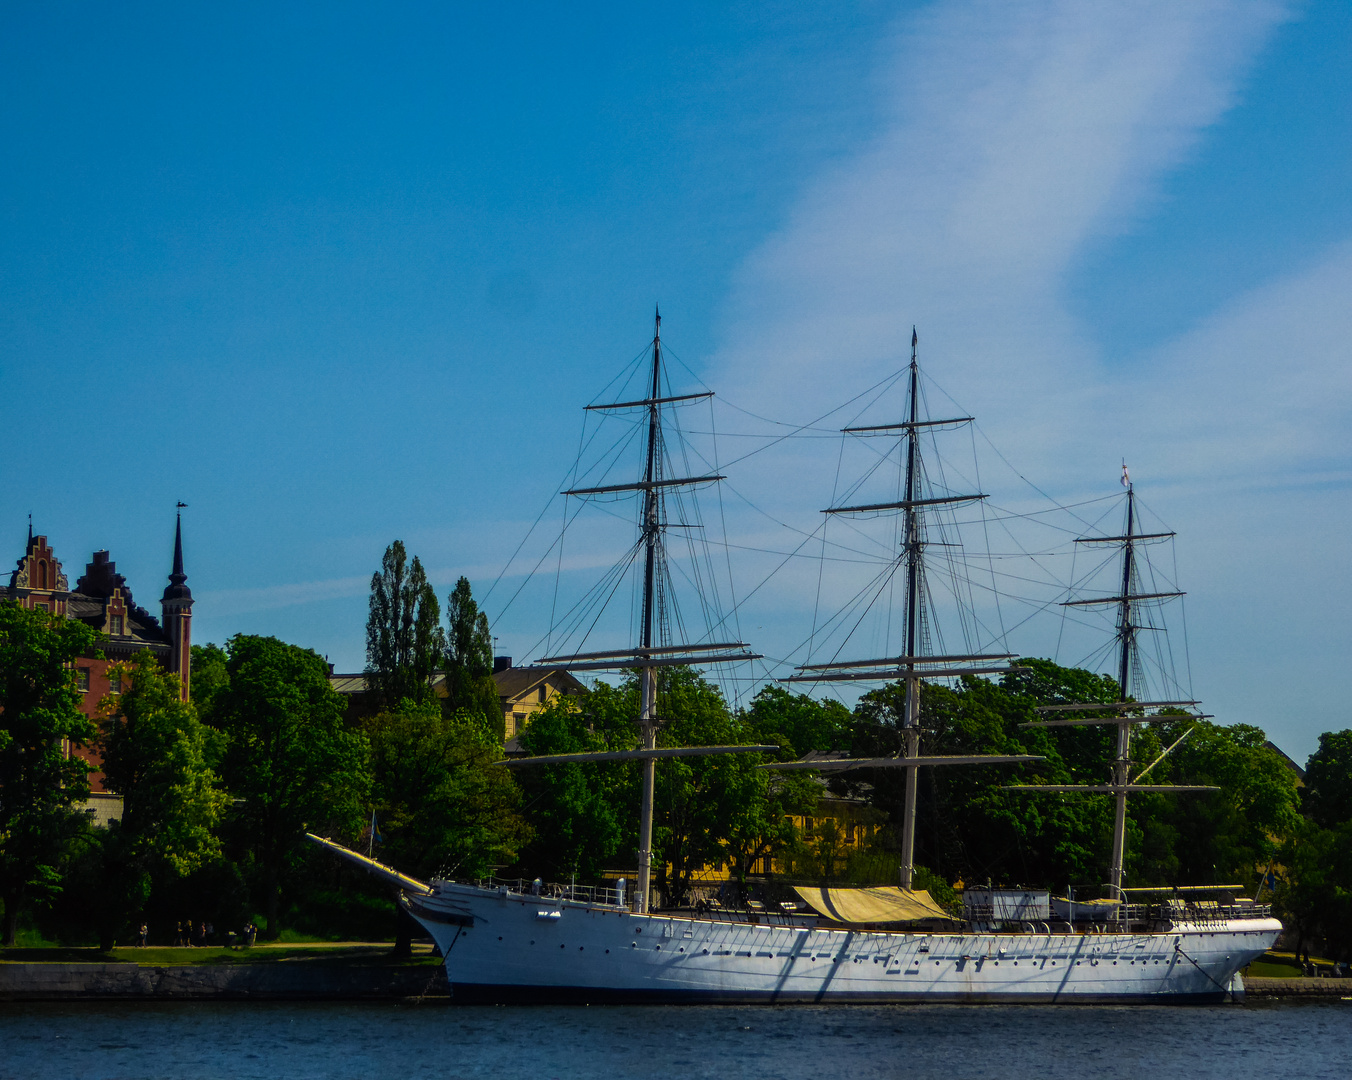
[214, 634, 370, 937]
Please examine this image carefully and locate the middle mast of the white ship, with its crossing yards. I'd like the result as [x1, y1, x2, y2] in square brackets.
[778, 327, 1042, 889]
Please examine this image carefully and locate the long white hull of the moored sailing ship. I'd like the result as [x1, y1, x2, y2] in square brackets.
[410, 883, 1282, 1004]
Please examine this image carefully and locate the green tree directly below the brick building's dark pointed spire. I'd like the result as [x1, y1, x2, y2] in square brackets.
[96, 652, 228, 949]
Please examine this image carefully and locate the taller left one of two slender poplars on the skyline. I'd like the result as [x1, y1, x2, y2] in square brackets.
[366, 541, 446, 707]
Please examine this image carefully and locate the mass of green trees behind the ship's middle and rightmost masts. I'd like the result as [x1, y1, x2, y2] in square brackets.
[838, 660, 1297, 887]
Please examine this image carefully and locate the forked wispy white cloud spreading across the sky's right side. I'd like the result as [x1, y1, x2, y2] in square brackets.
[711, 0, 1352, 749]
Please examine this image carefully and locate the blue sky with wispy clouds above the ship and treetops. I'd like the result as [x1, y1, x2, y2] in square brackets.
[0, 0, 1352, 757]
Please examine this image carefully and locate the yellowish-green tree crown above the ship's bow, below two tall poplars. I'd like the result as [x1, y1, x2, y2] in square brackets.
[364, 702, 529, 877]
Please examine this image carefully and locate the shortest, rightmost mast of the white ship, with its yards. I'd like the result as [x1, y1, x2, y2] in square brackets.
[1009, 462, 1218, 899]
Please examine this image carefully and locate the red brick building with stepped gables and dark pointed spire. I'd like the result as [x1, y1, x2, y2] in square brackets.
[0, 514, 192, 802]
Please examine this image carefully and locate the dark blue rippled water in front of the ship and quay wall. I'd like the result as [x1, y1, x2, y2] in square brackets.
[0, 1000, 1352, 1080]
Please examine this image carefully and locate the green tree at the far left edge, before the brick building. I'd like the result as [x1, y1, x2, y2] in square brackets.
[0, 600, 95, 945]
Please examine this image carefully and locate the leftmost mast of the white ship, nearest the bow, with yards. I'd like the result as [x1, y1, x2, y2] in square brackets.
[504, 311, 779, 911]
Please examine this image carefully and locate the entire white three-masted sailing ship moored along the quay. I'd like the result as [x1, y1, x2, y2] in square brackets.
[311, 316, 1282, 1004]
